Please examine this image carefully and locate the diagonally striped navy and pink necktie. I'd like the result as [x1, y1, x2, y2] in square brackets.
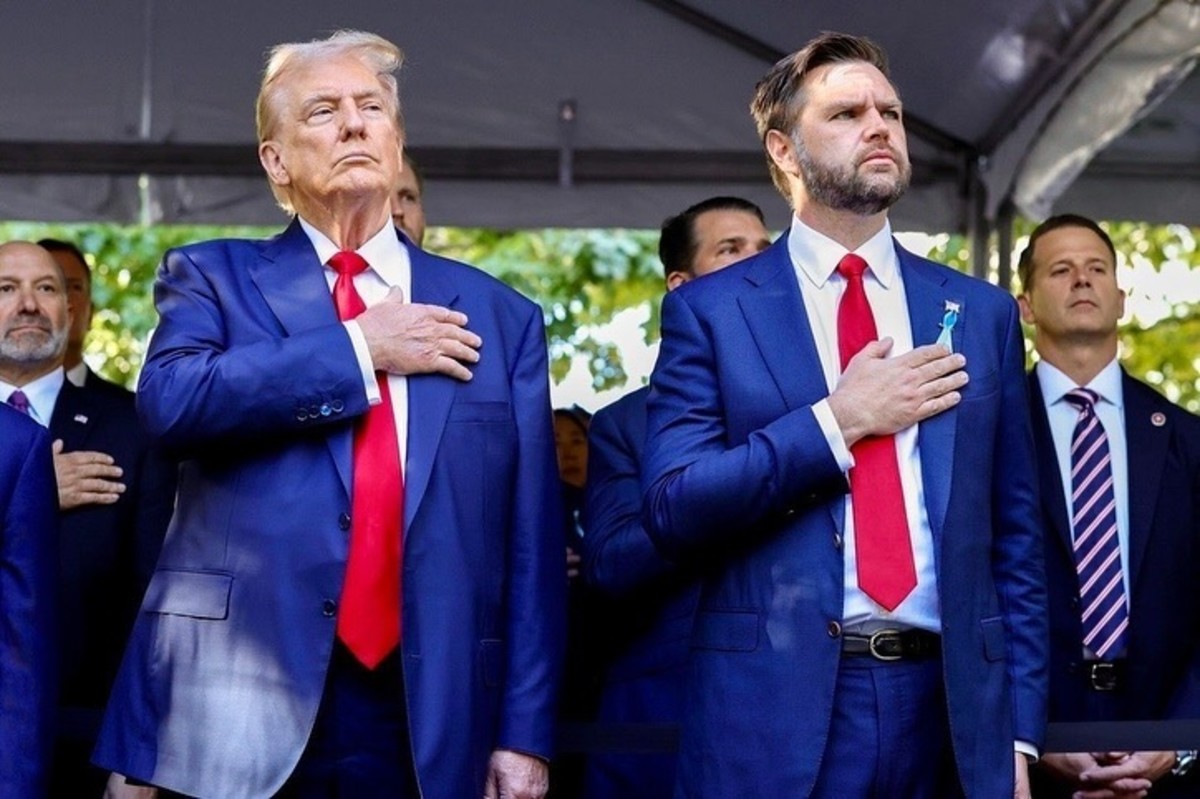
[1063, 389, 1129, 660]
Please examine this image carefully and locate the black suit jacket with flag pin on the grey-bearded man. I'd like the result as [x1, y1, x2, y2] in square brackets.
[50, 380, 175, 740]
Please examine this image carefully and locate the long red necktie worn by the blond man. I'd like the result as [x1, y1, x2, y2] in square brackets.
[329, 251, 404, 668]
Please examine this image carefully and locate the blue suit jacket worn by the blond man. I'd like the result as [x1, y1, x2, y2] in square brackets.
[96, 223, 565, 799]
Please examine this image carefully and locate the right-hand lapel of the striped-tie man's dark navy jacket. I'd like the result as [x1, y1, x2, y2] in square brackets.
[1121, 370, 1171, 593]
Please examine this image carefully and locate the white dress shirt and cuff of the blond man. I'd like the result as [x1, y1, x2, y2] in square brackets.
[300, 217, 413, 471]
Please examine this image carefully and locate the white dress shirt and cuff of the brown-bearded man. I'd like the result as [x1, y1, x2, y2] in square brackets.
[787, 216, 941, 632]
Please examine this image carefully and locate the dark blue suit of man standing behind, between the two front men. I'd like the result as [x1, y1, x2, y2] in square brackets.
[583, 389, 700, 799]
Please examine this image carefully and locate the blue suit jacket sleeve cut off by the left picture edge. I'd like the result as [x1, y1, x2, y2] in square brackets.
[0, 403, 59, 799]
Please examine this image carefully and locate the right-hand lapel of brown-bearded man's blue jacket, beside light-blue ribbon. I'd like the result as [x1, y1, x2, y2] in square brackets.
[896, 245, 968, 551]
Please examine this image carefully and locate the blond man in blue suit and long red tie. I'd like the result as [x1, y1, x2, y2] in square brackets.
[96, 31, 566, 799]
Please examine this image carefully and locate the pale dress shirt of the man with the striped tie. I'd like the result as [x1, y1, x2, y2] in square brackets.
[1033, 359, 1129, 607]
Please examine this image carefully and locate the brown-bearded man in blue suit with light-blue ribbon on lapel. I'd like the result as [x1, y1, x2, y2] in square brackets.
[643, 34, 1046, 799]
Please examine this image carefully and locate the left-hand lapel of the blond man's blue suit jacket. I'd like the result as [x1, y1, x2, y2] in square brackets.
[248, 220, 354, 495]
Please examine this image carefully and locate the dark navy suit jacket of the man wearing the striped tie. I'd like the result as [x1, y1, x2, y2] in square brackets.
[1030, 373, 1200, 721]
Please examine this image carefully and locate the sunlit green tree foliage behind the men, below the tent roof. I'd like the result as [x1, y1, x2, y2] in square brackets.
[0, 220, 1200, 410]
